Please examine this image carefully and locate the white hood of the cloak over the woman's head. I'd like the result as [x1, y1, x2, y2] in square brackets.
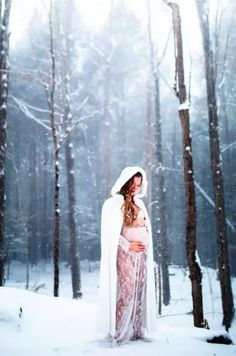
[111, 166, 148, 198]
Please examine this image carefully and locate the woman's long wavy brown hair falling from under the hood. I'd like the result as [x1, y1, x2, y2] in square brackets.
[118, 172, 143, 226]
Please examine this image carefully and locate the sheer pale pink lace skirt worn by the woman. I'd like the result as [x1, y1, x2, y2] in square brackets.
[113, 228, 147, 344]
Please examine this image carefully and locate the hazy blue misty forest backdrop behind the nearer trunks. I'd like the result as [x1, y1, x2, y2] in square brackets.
[6, 0, 236, 282]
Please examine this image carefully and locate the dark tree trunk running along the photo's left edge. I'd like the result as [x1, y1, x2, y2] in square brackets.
[0, 0, 11, 286]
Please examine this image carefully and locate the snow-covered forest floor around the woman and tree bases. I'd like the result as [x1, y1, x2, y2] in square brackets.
[0, 262, 236, 356]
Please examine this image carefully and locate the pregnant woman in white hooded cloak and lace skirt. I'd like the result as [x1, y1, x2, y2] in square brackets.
[98, 167, 156, 345]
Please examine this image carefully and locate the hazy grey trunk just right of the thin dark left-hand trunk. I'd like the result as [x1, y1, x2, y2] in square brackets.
[57, 1, 82, 299]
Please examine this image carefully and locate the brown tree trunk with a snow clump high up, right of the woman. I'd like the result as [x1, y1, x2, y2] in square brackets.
[167, 1, 204, 327]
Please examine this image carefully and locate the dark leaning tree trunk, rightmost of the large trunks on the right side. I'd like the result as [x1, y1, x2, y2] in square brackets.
[196, 0, 234, 330]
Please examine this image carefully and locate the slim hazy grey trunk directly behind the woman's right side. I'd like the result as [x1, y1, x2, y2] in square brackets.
[147, 0, 170, 305]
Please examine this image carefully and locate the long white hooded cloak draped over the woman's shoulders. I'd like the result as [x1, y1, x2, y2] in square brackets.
[98, 166, 156, 336]
